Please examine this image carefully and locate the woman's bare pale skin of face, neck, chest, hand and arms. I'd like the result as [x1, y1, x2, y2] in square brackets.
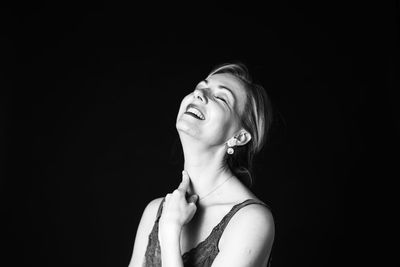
[129, 74, 275, 267]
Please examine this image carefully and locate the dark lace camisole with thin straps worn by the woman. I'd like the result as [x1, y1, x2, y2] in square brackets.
[143, 199, 271, 267]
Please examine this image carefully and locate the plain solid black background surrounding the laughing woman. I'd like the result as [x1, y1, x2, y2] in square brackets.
[0, 1, 399, 266]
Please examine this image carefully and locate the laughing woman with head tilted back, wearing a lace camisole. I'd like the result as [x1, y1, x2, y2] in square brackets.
[129, 64, 275, 267]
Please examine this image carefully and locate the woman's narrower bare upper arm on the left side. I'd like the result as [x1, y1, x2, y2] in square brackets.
[129, 198, 162, 267]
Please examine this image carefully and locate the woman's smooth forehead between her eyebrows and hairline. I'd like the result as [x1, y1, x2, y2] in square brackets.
[206, 73, 247, 111]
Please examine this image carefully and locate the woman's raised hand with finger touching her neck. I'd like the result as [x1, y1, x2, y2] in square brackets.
[159, 171, 198, 238]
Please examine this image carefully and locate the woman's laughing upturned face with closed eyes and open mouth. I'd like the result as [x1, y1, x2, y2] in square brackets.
[176, 73, 246, 146]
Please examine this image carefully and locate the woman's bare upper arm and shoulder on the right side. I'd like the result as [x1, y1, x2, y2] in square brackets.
[212, 205, 275, 267]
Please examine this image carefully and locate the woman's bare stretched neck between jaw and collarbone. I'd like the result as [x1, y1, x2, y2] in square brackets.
[182, 136, 233, 199]
